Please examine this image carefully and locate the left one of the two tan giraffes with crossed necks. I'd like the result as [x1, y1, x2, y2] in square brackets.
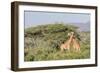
[60, 32, 74, 51]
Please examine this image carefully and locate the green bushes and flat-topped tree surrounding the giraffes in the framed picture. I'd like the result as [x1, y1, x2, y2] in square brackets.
[24, 23, 90, 61]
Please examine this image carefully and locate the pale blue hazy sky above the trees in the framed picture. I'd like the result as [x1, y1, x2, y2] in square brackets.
[24, 11, 90, 30]
